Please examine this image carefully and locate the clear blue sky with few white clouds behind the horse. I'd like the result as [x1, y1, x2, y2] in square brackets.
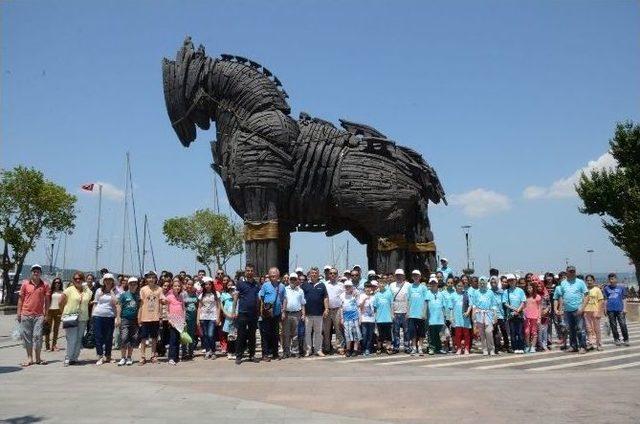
[0, 0, 640, 273]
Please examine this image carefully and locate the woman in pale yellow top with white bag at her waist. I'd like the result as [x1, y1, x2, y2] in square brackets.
[59, 272, 93, 367]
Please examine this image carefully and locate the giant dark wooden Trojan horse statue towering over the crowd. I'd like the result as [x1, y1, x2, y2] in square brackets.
[162, 38, 446, 274]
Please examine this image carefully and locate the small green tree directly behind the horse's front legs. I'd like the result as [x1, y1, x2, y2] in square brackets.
[162, 209, 244, 275]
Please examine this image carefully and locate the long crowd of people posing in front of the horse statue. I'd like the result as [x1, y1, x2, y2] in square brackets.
[17, 258, 629, 367]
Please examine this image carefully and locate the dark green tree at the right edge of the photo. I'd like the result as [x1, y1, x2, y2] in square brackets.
[576, 121, 640, 281]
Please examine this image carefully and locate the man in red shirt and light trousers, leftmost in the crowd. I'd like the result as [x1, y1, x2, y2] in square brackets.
[17, 265, 51, 367]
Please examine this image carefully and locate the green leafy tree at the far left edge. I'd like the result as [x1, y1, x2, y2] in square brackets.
[0, 166, 77, 302]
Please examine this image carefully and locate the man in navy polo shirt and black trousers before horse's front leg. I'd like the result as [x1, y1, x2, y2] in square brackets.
[233, 264, 260, 365]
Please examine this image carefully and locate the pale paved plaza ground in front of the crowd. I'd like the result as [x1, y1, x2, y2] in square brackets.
[0, 316, 640, 424]
